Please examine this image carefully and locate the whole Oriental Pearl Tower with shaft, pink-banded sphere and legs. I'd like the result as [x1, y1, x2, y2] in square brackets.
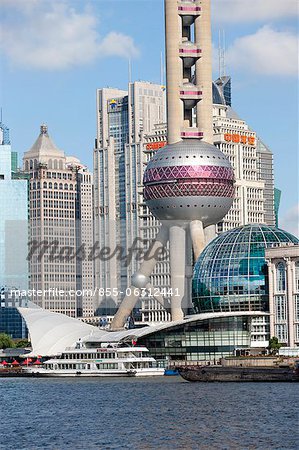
[111, 0, 235, 330]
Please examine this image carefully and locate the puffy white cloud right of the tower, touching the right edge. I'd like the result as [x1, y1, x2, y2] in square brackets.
[226, 25, 298, 76]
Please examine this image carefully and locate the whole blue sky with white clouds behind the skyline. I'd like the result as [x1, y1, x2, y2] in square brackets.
[0, 0, 299, 234]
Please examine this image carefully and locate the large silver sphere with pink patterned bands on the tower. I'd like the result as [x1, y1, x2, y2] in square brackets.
[143, 139, 235, 227]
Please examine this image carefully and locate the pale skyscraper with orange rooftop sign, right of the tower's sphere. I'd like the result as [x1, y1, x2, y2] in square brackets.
[213, 76, 275, 233]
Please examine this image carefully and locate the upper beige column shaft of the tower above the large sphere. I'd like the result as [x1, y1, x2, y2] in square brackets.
[165, 0, 213, 144]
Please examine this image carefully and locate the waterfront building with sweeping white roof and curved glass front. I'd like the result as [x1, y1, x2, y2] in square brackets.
[20, 308, 268, 366]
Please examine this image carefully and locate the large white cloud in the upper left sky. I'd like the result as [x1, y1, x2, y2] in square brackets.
[0, 0, 138, 70]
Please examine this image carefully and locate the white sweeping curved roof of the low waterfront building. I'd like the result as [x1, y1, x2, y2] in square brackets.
[18, 308, 269, 356]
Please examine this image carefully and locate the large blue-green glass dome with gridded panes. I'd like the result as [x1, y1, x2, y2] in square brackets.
[192, 224, 299, 313]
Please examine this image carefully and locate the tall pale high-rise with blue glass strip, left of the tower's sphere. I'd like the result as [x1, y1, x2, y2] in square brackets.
[94, 81, 165, 314]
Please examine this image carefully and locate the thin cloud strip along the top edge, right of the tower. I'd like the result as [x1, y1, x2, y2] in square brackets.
[212, 0, 299, 23]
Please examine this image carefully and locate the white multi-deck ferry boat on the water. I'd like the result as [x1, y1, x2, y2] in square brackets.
[24, 343, 164, 377]
